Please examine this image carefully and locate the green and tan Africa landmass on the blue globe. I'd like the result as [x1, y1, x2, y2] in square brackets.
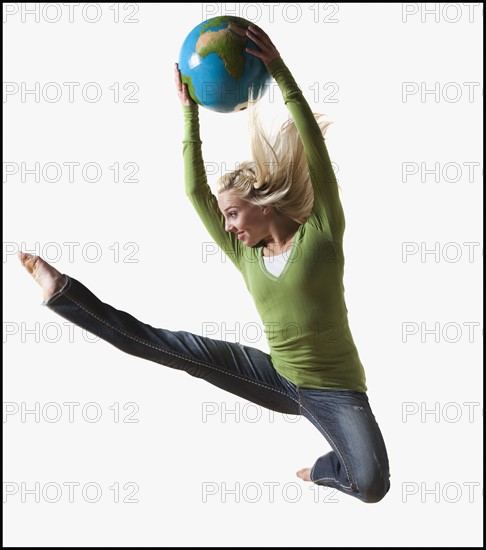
[196, 27, 246, 80]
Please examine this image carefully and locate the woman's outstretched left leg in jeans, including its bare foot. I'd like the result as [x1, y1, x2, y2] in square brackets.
[21, 257, 299, 414]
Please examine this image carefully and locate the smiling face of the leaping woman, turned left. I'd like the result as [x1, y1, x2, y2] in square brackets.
[218, 191, 268, 246]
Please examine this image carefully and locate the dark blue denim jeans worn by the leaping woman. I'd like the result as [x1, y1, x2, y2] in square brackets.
[43, 275, 390, 502]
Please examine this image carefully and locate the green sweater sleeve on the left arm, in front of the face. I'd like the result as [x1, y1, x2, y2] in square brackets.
[182, 106, 241, 269]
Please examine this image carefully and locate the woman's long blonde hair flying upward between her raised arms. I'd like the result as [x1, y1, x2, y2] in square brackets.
[216, 100, 332, 224]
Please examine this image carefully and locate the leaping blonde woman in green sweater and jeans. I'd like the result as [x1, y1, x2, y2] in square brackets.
[19, 26, 390, 502]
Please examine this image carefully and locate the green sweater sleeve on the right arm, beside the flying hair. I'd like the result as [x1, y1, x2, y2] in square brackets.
[268, 58, 344, 239]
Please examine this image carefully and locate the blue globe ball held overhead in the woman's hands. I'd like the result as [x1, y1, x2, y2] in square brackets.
[179, 16, 271, 113]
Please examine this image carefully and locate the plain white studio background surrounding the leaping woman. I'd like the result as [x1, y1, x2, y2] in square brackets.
[3, 3, 483, 546]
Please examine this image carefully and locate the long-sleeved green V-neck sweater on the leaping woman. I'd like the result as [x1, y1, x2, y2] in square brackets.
[183, 59, 367, 392]
